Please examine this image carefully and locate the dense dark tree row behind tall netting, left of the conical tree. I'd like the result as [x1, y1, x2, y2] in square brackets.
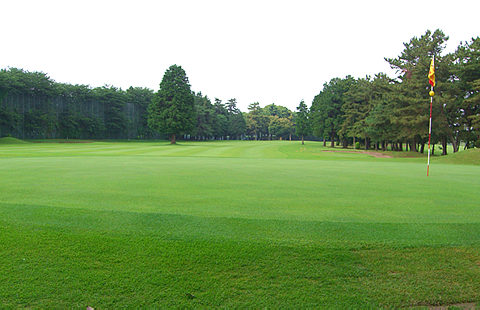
[0, 68, 153, 139]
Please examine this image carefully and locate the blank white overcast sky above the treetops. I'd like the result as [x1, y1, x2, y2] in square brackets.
[0, 0, 480, 111]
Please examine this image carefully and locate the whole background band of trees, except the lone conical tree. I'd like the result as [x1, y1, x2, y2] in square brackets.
[0, 30, 480, 154]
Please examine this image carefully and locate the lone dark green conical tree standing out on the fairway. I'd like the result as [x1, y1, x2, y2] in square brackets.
[148, 65, 195, 144]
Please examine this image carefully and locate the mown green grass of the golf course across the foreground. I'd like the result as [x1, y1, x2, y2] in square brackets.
[0, 141, 480, 308]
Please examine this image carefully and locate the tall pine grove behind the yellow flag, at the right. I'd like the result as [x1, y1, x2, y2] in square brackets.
[310, 30, 480, 154]
